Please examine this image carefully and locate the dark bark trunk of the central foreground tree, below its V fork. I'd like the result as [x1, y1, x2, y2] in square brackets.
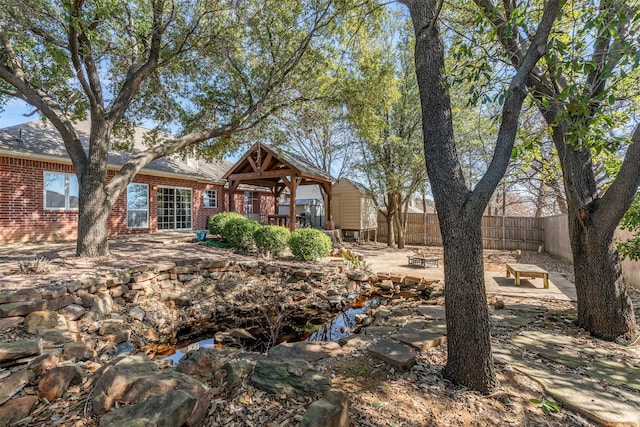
[438, 213, 498, 392]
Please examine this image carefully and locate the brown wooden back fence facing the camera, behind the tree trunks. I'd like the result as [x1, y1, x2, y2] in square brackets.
[378, 213, 544, 251]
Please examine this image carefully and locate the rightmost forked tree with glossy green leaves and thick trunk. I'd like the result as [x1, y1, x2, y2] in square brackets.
[474, 0, 640, 339]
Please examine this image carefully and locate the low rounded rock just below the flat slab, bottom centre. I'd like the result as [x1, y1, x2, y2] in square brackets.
[251, 359, 331, 396]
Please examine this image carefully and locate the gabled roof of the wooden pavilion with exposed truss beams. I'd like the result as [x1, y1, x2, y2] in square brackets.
[223, 142, 334, 187]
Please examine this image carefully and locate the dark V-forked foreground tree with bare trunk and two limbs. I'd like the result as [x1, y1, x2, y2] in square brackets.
[402, 0, 562, 391]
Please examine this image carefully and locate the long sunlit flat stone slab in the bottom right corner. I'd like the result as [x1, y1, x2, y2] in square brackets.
[516, 362, 640, 427]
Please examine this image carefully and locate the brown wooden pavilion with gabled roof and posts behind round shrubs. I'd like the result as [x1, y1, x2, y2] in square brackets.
[223, 142, 334, 230]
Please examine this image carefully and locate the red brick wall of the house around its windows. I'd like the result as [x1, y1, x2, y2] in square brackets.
[0, 156, 273, 243]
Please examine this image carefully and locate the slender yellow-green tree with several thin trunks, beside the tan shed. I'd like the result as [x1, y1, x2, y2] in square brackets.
[345, 16, 426, 248]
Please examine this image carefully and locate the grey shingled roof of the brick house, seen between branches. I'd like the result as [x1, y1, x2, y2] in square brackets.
[0, 120, 232, 183]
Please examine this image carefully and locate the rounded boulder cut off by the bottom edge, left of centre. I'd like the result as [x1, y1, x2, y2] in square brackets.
[99, 390, 200, 427]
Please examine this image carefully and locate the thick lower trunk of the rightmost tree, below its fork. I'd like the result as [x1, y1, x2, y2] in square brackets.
[569, 209, 636, 340]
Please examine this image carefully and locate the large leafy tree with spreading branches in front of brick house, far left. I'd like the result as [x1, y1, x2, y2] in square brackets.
[0, 0, 376, 256]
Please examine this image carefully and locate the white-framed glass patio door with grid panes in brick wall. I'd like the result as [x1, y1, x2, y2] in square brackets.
[158, 187, 192, 230]
